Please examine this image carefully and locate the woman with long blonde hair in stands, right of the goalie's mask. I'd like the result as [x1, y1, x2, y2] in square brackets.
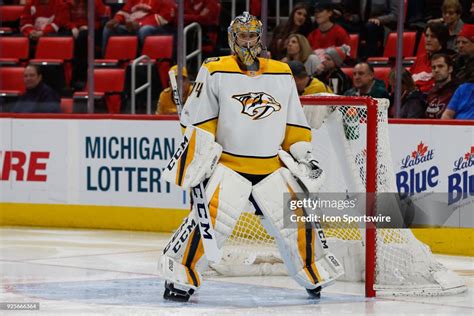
[281, 34, 321, 75]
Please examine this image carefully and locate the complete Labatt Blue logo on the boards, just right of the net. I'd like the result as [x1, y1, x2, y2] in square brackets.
[397, 142, 439, 199]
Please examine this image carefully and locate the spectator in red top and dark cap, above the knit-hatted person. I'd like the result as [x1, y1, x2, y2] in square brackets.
[308, 1, 350, 50]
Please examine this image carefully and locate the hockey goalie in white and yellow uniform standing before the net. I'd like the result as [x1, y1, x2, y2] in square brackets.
[159, 12, 343, 301]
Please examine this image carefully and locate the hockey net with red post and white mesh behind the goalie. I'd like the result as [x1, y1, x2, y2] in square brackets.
[206, 96, 466, 296]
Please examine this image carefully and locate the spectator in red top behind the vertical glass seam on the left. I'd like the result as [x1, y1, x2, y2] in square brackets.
[67, 0, 110, 90]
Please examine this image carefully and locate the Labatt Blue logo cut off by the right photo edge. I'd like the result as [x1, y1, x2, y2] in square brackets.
[448, 146, 474, 205]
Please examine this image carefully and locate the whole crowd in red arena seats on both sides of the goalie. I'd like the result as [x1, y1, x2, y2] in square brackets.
[0, 0, 474, 119]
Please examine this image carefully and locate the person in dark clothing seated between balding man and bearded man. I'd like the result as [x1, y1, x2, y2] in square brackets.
[389, 68, 426, 118]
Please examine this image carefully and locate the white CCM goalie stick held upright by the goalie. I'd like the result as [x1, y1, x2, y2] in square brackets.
[168, 70, 222, 263]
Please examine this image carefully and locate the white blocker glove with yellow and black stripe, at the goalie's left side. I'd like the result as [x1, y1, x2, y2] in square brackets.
[163, 126, 222, 189]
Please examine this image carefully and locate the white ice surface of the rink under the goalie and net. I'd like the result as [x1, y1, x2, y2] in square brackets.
[0, 228, 474, 316]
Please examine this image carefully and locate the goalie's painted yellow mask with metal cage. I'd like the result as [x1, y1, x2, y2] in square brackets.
[228, 12, 263, 66]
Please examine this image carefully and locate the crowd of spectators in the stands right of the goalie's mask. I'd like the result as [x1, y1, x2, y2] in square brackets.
[270, 0, 474, 119]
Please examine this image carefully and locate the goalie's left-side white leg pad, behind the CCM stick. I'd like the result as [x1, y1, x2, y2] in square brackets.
[159, 164, 252, 289]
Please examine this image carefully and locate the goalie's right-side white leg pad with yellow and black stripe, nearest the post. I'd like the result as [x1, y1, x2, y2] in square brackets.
[252, 168, 343, 290]
